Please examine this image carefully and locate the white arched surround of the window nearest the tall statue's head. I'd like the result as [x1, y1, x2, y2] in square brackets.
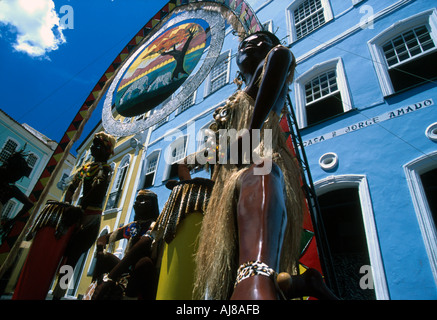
[294, 58, 352, 129]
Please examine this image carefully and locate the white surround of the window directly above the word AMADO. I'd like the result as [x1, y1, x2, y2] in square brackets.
[367, 9, 437, 96]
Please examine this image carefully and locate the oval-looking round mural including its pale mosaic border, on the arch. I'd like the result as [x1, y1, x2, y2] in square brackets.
[102, 9, 225, 136]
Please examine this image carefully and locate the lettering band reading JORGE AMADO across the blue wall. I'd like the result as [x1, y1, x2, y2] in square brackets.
[303, 99, 434, 147]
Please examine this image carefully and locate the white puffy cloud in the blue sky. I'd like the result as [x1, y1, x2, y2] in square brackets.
[0, 0, 66, 57]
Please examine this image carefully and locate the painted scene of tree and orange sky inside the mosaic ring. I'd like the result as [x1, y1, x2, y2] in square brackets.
[113, 19, 211, 117]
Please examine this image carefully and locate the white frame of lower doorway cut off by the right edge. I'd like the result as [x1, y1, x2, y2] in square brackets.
[404, 151, 437, 284]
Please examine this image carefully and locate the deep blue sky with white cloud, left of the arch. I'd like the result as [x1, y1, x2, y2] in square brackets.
[0, 0, 168, 153]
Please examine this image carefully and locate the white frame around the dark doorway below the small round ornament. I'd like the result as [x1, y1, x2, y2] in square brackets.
[314, 175, 390, 300]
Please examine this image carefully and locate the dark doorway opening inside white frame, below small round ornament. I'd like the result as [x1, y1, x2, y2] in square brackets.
[318, 187, 376, 300]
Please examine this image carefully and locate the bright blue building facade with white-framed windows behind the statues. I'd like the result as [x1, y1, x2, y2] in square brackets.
[124, 0, 437, 299]
